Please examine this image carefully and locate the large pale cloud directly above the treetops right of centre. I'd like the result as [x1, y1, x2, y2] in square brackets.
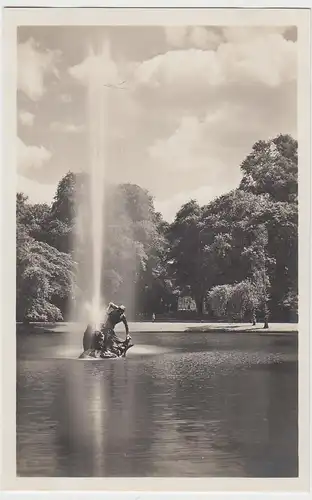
[148, 90, 295, 219]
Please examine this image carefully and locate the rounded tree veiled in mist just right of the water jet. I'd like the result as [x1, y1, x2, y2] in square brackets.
[104, 184, 172, 312]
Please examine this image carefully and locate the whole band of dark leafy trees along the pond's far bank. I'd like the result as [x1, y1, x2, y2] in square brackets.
[16, 135, 298, 328]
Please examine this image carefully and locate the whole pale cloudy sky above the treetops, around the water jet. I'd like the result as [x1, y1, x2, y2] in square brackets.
[17, 26, 297, 221]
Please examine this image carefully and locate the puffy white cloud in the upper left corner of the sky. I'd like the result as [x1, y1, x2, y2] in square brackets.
[17, 38, 60, 101]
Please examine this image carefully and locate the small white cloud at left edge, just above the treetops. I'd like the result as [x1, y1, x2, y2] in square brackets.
[17, 137, 52, 174]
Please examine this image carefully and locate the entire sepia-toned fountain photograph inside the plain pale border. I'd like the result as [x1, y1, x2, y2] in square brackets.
[4, 5, 310, 490]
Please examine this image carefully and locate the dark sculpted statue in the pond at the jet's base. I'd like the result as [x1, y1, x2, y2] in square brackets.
[80, 302, 133, 359]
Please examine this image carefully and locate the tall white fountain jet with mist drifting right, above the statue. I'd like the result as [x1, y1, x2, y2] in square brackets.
[68, 39, 136, 332]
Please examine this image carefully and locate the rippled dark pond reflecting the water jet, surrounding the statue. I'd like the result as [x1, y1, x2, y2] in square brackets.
[17, 328, 298, 477]
